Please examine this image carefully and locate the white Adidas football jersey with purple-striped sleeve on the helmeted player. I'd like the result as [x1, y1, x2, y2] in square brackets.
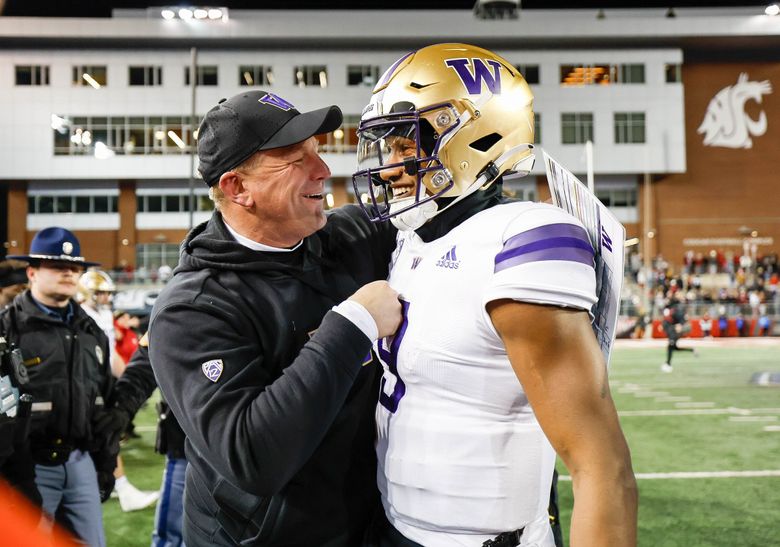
[376, 202, 596, 547]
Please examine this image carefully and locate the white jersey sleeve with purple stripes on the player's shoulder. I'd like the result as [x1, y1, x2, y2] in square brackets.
[483, 203, 597, 310]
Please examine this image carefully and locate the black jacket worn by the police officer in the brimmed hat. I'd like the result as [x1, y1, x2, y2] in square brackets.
[0, 289, 119, 474]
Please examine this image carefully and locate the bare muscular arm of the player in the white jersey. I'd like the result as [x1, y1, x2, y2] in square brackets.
[487, 299, 637, 547]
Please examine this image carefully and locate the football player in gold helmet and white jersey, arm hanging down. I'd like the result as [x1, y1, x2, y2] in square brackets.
[353, 44, 637, 547]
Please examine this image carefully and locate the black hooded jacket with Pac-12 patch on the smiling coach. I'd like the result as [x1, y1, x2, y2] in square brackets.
[149, 206, 395, 547]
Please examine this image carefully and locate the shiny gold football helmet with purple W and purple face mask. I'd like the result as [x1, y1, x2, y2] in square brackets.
[352, 44, 534, 230]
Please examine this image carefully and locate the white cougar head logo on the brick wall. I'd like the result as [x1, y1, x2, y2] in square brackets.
[698, 72, 772, 148]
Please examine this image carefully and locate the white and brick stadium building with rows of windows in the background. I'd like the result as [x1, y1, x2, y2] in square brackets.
[0, 7, 780, 284]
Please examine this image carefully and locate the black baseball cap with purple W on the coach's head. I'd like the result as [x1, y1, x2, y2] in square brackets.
[198, 90, 342, 186]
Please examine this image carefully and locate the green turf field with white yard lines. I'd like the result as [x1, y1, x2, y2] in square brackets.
[103, 341, 780, 547]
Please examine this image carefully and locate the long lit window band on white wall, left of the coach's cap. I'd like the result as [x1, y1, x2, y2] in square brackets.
[52, 115, 198, 156]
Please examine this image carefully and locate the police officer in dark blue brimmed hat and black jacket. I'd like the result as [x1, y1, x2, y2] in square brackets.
[0, 227, 118, 546]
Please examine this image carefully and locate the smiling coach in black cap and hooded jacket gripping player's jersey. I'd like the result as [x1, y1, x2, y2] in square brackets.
[149, 91, 401, 547]
